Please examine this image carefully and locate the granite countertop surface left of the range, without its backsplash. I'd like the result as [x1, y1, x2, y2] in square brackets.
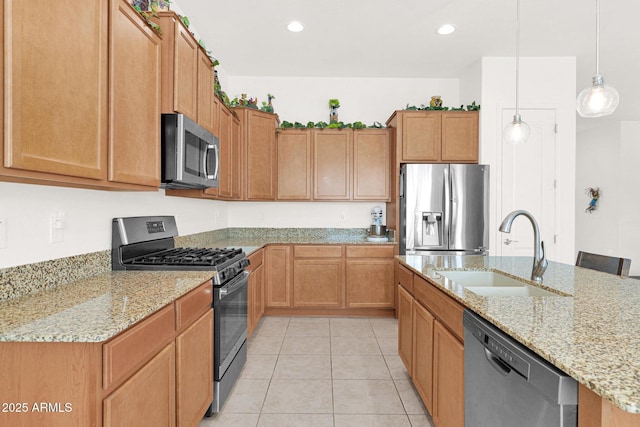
[0, 271, 214, 342]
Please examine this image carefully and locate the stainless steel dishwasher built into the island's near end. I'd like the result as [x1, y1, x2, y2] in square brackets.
[463, 310, 578, 427]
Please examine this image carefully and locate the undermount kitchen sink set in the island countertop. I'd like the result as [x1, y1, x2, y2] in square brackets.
[436, 271, 562, 297]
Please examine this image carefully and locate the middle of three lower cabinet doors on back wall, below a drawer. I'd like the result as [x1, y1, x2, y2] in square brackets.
[293, 258, 344, 308]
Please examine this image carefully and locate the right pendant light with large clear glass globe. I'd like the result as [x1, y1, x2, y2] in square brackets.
[576, 0, 620, 117]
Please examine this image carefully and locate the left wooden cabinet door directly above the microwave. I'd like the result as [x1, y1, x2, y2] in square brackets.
[173, 19, 199, 120]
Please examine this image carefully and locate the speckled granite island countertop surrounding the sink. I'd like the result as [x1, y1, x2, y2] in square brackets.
[398, 255, 640, 413]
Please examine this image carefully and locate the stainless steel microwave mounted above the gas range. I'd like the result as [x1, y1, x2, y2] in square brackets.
[161, 114, 220, 189]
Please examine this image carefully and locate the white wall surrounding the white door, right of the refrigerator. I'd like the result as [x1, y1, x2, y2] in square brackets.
[480, 57, 576, 263]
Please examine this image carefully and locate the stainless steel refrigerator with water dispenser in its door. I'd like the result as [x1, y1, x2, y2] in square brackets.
[399, 164, 489, 255]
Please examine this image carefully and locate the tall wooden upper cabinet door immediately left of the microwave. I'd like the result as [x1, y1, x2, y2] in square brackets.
[109, 0, 161, 187]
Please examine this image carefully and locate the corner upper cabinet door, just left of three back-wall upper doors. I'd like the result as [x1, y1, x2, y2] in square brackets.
[242, 109, 277, 200]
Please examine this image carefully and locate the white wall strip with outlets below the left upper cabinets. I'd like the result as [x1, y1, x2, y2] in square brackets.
[0, 182, 227, 268]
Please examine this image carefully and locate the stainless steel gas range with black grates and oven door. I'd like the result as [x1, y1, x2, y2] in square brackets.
[111, 216, 249, 416]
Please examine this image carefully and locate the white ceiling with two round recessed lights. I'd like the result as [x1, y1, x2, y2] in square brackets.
[175, 0, 640, 129]
